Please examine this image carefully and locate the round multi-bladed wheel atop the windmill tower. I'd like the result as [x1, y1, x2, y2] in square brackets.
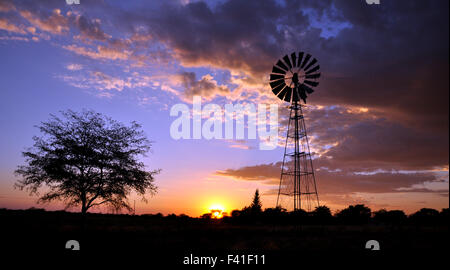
[270, 52, 320, 103]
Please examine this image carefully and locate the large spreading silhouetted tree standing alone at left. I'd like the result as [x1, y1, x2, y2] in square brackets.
[15, 110, 158, 219]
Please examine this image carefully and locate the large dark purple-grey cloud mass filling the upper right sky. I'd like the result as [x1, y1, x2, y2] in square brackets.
[115, 0, 449, 158]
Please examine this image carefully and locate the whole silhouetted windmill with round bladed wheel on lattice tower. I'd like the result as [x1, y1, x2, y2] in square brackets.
[270, 52, 320, 211]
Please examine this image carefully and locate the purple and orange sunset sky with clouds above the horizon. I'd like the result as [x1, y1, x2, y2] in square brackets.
[0, 0, 449, 216]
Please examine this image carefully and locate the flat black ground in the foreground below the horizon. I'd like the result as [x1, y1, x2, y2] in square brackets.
[0, 209, 449, 266]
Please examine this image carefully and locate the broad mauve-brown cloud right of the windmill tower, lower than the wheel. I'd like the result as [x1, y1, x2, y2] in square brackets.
[306, 107, 449, 170]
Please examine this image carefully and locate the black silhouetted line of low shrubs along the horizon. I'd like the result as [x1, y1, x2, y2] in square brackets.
[0, 204, 449, 227]
